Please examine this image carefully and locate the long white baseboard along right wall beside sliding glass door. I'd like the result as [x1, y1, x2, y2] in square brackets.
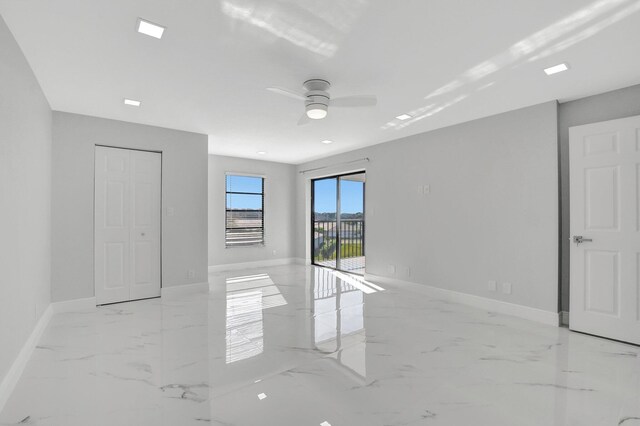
[365, 274, 560, 327]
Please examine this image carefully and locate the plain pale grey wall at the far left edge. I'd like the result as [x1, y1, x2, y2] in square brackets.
[0, 18, 51, 383]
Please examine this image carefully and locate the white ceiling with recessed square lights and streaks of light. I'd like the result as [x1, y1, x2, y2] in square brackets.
[0, 0, 640, 163]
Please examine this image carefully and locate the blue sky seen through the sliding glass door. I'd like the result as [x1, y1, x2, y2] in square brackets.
[313, 178, 364, 213]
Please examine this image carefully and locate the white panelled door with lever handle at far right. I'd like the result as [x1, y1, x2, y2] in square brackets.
[569, 116, 640, 344]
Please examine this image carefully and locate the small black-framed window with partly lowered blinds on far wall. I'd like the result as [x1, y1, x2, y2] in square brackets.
[224, 175, 264, 247]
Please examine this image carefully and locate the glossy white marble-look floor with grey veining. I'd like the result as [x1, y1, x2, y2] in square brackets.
[0, 266, 640, 426]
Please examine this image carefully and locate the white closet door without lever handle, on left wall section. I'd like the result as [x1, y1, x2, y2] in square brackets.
[95, 147, 162, 305]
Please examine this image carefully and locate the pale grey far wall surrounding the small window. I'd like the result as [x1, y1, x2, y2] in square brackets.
[209, 155, 297, 266]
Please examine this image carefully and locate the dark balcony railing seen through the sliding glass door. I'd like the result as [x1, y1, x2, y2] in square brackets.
[313, 219, 364, 262]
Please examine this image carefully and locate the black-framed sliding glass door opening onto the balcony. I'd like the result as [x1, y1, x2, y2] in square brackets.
[311, 172, 365, 274]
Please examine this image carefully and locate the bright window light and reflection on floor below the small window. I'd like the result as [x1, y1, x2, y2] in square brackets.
[226, 274, 287, 364]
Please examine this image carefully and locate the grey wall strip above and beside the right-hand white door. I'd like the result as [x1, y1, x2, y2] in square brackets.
[558, 85, 640, 311]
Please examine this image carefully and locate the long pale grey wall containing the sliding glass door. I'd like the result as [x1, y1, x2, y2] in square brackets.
[296, 102, 558, 312]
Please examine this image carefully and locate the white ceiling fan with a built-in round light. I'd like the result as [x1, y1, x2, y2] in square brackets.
[267, 78, 378, 126]
